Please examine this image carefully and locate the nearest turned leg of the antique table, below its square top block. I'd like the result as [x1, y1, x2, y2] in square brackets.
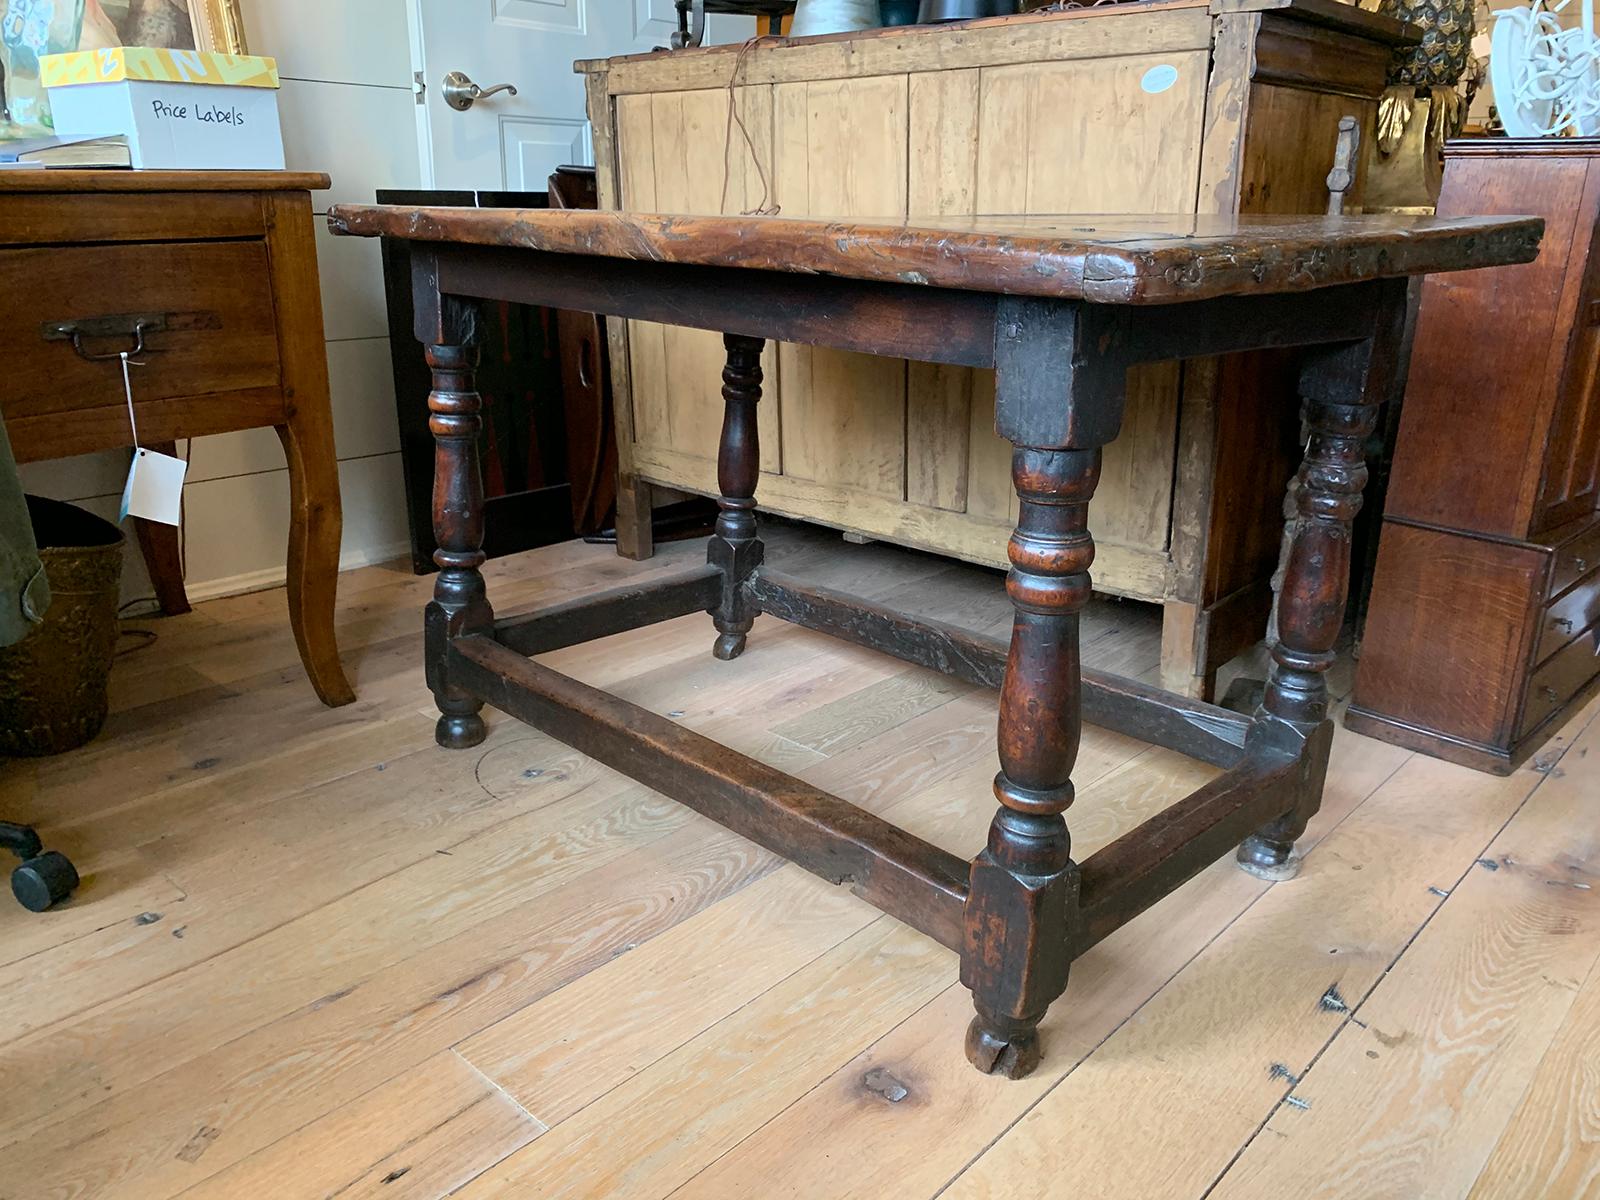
[962, 446, 1101, 1078]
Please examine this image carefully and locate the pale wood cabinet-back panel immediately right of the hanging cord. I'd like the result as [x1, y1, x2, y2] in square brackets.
[773, 75, 907, 498]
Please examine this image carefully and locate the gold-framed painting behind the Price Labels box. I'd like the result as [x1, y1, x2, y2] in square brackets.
[0, 0, 248, 138]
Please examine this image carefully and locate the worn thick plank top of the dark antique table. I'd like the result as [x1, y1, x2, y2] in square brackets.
[328, 205, 1544, 304]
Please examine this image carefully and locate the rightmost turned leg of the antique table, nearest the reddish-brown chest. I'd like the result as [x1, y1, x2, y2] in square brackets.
[1238, 329, 1390, 880]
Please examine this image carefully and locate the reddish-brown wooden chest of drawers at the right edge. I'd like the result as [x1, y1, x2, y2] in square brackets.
[1346, 138, 1600, 773]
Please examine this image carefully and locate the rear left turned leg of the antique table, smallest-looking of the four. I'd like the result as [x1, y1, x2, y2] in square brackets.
[706, 333, 765, 659]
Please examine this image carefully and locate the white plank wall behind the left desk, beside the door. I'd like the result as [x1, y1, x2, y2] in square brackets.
[22, 0, 421, 611]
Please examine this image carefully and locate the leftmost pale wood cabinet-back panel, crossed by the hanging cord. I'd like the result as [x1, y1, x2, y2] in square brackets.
[618, 86, 782, 472]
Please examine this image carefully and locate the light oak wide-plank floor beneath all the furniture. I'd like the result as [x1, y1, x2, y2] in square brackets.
[0, 528, 1600, 1200]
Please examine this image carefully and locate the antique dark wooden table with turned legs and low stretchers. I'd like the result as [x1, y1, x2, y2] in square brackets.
[330, 206, 1542, 1077]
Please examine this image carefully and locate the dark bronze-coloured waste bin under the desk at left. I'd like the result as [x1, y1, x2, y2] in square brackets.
[0, 496, 123, 757]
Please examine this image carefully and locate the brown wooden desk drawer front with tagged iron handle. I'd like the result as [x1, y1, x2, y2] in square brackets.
[0, 242, 280, 418]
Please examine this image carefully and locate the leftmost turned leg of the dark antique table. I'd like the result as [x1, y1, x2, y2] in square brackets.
[424, 296, 494, 750]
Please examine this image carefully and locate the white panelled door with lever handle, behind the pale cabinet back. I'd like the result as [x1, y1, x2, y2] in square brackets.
[411, 0, 755, 192]
